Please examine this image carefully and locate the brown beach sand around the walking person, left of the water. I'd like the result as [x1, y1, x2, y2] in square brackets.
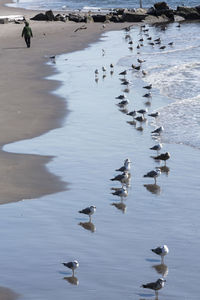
[0, 1, 136, 204]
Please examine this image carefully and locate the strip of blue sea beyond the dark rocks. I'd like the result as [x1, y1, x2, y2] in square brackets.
[7, 0, 199, 10]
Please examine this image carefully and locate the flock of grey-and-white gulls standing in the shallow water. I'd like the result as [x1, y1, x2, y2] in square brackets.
[63, 25, 173, 296]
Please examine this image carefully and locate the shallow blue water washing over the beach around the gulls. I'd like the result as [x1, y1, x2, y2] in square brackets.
[0, 23, 200, 300]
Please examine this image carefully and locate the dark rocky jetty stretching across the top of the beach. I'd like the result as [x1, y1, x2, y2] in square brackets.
[31, 2, 200, 23]
